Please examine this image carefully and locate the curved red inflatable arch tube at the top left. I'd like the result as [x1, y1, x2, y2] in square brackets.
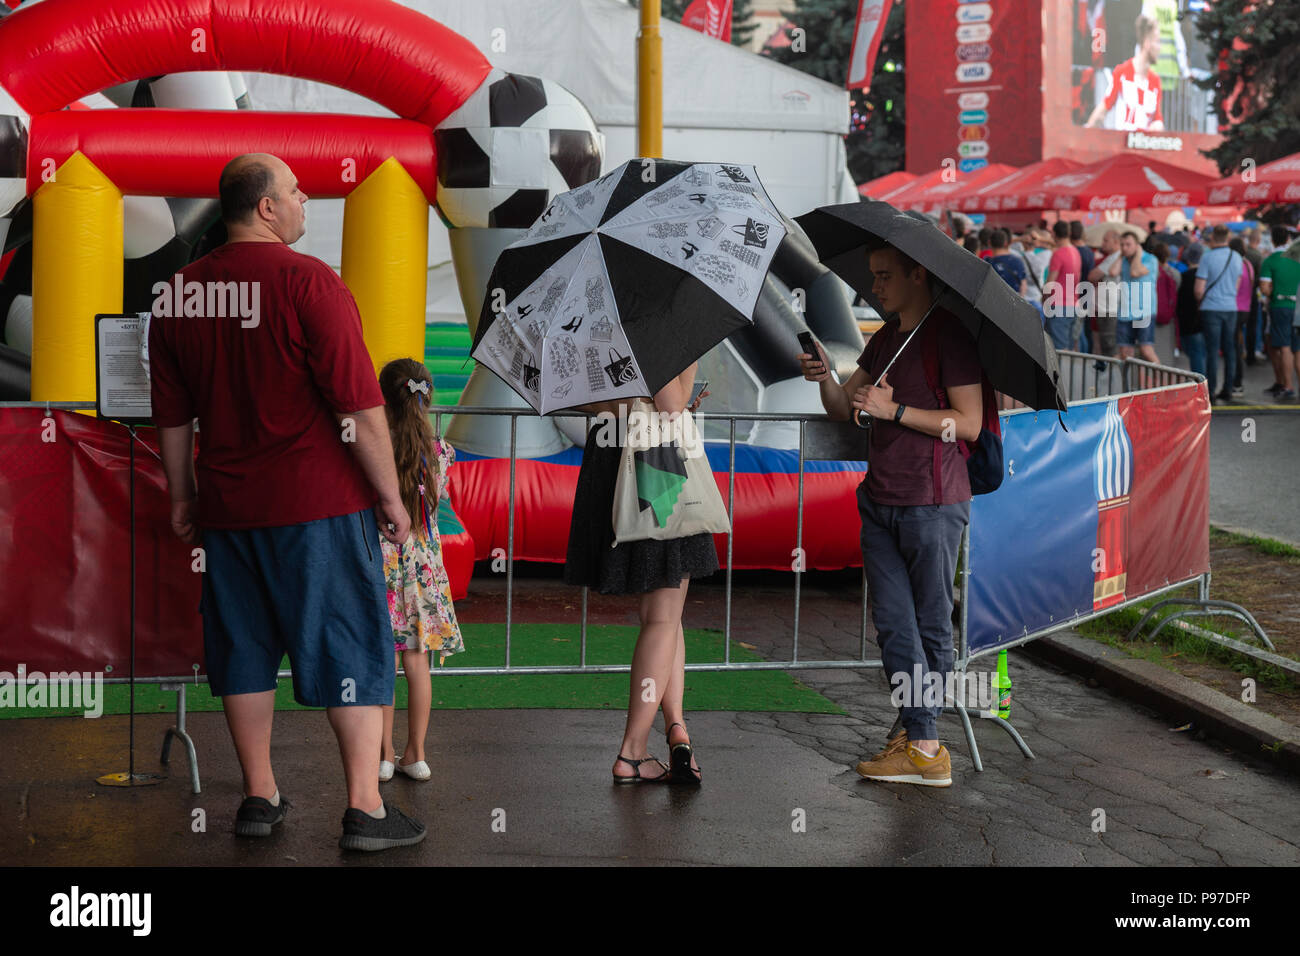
[0, 0, 491, 129]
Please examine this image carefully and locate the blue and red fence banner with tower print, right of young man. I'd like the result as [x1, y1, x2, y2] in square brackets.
[967, 385, 1210, 650]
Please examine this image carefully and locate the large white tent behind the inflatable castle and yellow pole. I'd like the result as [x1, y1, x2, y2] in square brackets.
[246, 0, 858, 321]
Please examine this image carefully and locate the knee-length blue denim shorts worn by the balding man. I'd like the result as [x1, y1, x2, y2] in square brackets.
[199, 509, 394, 708]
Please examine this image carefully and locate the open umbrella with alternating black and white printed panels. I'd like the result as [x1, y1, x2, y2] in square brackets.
[472, 160, 785, 415]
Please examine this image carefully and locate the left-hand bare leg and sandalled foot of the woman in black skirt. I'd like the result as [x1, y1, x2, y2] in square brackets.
[614, 579, 689, 778]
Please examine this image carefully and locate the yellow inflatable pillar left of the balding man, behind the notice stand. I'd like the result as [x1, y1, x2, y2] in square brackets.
[31, 152, 122, 402]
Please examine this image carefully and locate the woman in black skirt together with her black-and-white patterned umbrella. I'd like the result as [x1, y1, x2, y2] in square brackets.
[472, 159, 785, 784]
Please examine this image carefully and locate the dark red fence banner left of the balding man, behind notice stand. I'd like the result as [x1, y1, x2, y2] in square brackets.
[0, 408, 203, 678]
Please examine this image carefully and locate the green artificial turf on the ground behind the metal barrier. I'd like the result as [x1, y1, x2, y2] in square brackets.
[0, 624, 845, 718]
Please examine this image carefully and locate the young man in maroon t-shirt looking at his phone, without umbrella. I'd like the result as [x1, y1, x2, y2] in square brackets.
[801, 247, 983, 787]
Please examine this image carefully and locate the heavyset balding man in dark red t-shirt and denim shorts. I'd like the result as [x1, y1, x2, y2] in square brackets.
[148, 153, 425, 849]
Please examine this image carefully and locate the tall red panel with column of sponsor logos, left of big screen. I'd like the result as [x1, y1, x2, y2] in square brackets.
[906, 0, 1043, 173]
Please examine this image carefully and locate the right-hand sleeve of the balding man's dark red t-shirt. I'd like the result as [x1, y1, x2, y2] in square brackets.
[299, 287, 384, 412]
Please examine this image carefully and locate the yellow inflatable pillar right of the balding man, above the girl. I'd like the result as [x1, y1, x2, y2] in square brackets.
[342, 156, 429, 375]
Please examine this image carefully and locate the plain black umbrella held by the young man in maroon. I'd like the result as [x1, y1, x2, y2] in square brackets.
[794, 200, 1066, 410]
